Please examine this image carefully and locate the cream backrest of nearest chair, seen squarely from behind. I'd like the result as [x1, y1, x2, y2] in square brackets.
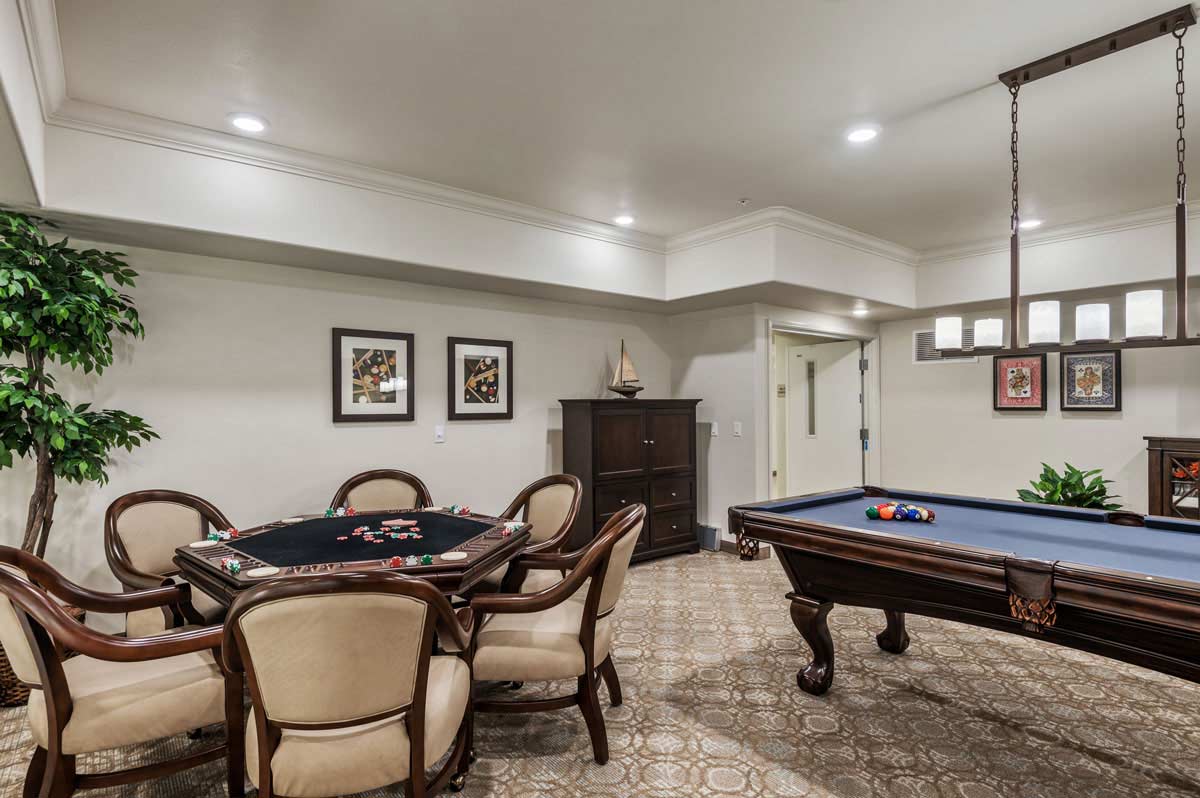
[224, 572, 439, 727]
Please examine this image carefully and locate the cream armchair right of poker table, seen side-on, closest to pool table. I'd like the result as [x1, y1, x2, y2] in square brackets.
[470, 504, 646, 764]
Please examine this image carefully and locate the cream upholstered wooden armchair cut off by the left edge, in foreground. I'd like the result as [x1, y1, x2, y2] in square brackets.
[0, 546, 244, 798]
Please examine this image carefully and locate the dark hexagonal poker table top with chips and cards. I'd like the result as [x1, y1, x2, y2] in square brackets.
[174, 508, 532, 606]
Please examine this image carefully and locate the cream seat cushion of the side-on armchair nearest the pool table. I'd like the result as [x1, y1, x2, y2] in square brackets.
[475, 599, 612, 682]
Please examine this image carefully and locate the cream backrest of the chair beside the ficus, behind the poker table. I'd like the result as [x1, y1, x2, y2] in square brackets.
[104, 491, 233, 575]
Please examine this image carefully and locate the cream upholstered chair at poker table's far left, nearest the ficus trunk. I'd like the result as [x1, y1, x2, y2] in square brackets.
[104, 491, 233, 637]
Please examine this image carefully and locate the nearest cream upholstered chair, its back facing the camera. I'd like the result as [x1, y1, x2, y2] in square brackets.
[223, 572, 472, 798]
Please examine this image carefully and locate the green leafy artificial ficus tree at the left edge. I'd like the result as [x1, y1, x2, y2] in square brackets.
[0, 208, 158, 557]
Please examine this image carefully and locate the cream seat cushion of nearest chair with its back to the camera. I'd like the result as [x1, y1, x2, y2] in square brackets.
[246, 656, 470, 798]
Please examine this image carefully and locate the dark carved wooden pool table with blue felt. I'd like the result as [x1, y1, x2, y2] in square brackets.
[730, 486, 1200, 695]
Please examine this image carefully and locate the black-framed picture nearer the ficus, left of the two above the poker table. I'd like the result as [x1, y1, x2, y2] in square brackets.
[334, 328, 415, 421]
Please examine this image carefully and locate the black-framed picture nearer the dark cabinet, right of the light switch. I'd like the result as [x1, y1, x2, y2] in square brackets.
[446, 338, 512, 421]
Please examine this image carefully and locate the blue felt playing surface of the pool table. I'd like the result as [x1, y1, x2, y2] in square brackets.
[758, 491, 1200, 582]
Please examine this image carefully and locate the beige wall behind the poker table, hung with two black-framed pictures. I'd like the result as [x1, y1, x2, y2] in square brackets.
[0, 251, 671, 586]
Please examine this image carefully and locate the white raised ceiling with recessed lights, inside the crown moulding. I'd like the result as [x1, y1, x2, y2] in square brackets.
[56, 0, 1180, 250]
